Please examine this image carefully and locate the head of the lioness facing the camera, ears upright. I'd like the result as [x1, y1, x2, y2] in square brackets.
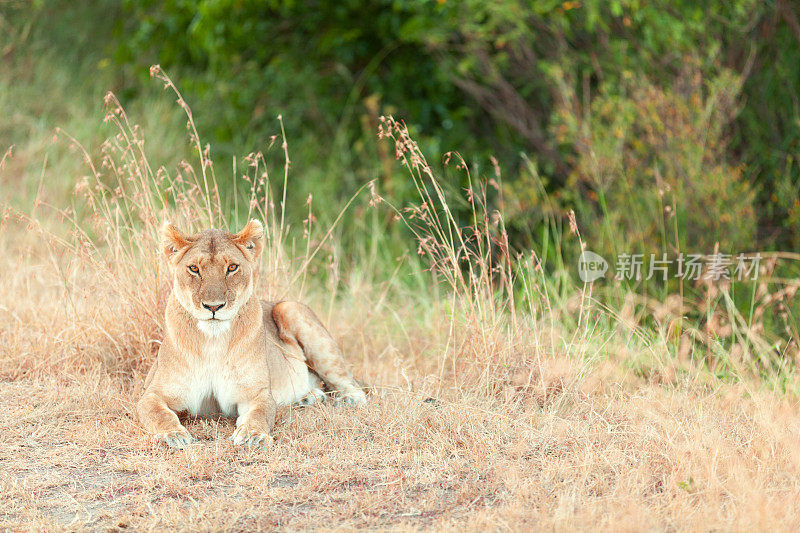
[162, 220, 264, 331]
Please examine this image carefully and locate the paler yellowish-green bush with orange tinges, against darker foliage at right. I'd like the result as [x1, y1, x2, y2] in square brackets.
[553, 65, 756, 254]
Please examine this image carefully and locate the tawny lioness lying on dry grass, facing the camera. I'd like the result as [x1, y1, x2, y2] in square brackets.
[137, 220, 366, 448]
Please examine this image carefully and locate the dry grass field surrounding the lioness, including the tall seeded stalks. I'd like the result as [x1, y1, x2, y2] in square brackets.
[0, 74, 800, 531]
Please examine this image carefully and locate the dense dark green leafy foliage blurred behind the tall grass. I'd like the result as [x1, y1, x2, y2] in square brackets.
[115, 0, 800, 247]
